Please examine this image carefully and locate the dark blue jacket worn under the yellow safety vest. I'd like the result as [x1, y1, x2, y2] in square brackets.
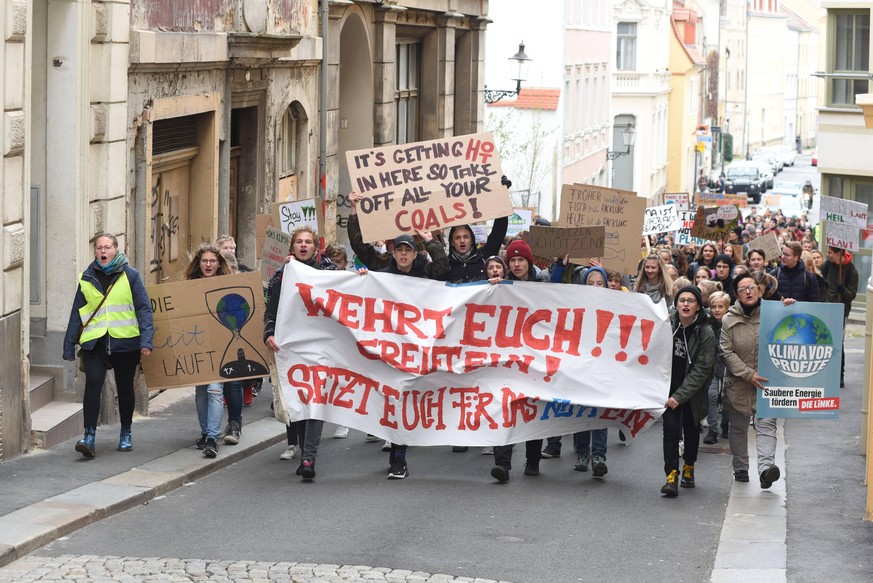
[64, 259, 155, 360]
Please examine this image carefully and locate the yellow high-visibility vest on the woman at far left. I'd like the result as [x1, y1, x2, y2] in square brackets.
[79, 273, 139, 344]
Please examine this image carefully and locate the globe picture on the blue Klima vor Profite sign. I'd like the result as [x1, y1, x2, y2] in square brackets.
[767, 313, 834, 378]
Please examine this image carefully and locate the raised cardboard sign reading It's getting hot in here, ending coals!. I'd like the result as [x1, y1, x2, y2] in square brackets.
[346, 132, 512, 243]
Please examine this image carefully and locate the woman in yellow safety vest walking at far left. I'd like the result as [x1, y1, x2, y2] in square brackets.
[64, 233, 154, 458]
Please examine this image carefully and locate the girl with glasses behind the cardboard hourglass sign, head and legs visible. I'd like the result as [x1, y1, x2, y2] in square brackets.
[182, 243, 243, 458]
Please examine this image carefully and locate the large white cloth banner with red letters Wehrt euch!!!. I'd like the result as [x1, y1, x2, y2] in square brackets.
[275, 261, 672, 446]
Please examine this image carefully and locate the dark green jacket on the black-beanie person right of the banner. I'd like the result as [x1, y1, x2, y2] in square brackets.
[670, 314, 715, 424]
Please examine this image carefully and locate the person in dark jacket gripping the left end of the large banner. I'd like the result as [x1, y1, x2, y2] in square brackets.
[264, 225, 336, 482]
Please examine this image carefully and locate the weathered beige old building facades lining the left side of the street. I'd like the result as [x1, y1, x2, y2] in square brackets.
[0, 0, 488, 464]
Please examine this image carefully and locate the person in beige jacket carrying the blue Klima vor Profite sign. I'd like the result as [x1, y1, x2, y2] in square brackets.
[721, 271, 793, 489]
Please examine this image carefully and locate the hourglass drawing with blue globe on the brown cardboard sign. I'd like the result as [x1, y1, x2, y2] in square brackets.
[206, 286, 269, 379]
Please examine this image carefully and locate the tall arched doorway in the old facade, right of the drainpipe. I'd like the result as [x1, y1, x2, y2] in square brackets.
[337, 13, 373, 242]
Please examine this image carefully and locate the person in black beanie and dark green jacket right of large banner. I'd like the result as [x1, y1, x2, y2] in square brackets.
[661, 285, 715, 498]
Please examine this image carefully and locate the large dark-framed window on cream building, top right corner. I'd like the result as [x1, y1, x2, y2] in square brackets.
[829, 11, 870, 106]
